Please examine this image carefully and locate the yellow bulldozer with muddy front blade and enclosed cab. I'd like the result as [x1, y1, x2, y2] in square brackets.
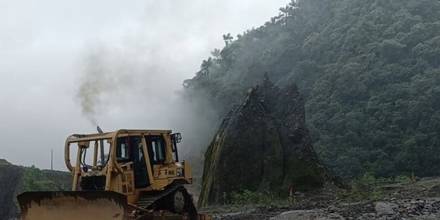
[17, 127, 210, 220]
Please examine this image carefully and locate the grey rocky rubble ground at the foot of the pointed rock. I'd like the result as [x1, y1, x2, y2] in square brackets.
[206, 177, 440, 220]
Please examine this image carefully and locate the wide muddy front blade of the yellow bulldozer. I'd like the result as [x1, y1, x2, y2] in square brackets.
[17, 191, 128, 220]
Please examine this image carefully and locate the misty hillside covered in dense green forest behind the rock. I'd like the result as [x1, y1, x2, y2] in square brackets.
[184, 0, 440, 177]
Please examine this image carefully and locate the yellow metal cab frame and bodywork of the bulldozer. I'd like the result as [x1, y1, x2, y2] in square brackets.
[64, 129, 192, 204]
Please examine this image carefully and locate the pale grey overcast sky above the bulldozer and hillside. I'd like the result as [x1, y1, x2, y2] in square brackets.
[0, 0, 289, 169]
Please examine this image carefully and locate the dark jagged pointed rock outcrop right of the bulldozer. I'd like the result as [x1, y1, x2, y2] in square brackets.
[199, 78, 334, 206]
